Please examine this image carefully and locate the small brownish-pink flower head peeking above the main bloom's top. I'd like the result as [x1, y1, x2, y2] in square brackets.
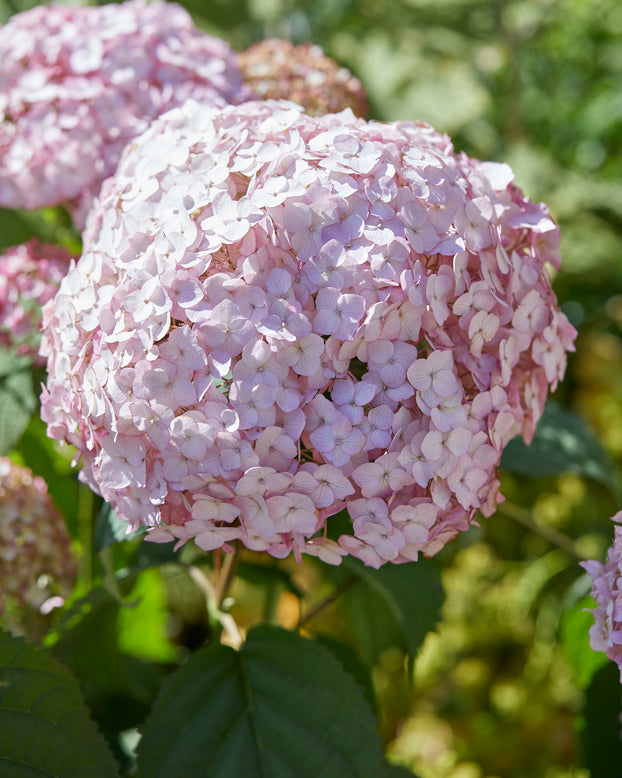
[238, 39, 367, 116]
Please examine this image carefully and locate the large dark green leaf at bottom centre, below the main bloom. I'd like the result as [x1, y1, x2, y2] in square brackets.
[138, 625, 383, 778]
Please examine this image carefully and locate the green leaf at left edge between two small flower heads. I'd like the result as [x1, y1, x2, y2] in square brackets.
[0, 349, 37, 455]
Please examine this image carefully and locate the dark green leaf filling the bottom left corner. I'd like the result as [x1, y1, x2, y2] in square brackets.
[0, 632, 119, 778]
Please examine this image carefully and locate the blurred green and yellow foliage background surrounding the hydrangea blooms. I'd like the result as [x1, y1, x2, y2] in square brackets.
[0, 0, 622, 778]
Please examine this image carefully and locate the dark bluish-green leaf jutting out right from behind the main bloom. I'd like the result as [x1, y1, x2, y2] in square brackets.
[501, 401, 622, 495]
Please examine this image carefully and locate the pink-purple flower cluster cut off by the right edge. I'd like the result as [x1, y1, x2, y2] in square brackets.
[582, 511, 622, 681]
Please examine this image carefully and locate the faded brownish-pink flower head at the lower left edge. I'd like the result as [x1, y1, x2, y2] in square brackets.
[0, 457, 76, 613]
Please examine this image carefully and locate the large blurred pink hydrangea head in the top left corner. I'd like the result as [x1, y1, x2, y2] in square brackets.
[0, 0, 251, 226]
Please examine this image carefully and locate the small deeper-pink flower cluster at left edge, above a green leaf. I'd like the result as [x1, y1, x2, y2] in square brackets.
[0, 238, 71, 363]
